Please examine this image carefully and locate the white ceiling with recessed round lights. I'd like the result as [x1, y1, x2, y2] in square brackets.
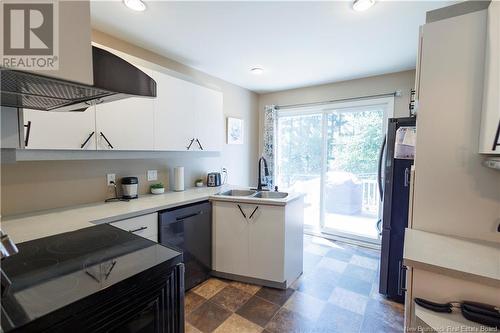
[91, 0, 452, 92]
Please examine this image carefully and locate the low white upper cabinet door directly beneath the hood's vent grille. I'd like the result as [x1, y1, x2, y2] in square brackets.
[23, 107, 96, 150]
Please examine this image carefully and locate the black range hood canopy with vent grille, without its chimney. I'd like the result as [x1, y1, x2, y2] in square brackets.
[0, 46, 156, 111]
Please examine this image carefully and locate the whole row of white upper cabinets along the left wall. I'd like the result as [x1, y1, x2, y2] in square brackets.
[19, 47, 224, 151]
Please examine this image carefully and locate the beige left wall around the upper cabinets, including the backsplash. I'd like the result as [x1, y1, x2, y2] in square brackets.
[1, 30, 258, 216]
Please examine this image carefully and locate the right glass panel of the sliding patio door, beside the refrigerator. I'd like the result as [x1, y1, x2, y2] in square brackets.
[322, 106, 385, 240]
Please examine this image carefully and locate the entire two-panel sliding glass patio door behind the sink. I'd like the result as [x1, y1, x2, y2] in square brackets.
[277, 98, 393, 242]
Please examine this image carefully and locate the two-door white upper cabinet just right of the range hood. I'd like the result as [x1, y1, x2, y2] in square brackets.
[153, 72, 224, 151]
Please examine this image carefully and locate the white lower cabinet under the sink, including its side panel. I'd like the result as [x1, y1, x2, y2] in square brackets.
[212, 197, 304, 287]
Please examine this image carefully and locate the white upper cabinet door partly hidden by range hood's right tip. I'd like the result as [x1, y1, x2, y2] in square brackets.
[96, 65, 155, 150]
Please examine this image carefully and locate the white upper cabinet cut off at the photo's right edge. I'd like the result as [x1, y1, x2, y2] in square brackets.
[479, 1, 500, 154]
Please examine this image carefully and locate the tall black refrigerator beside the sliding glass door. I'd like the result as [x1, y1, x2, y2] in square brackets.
[379, 118, 416, 303]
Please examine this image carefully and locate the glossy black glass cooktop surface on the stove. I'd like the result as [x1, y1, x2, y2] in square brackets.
[2, 224, 182, 331]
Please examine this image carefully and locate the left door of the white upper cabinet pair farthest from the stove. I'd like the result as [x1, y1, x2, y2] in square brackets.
[153, 71, 196, 151]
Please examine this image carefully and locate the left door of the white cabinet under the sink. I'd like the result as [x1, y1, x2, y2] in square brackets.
[212, 202, 251, 276]
